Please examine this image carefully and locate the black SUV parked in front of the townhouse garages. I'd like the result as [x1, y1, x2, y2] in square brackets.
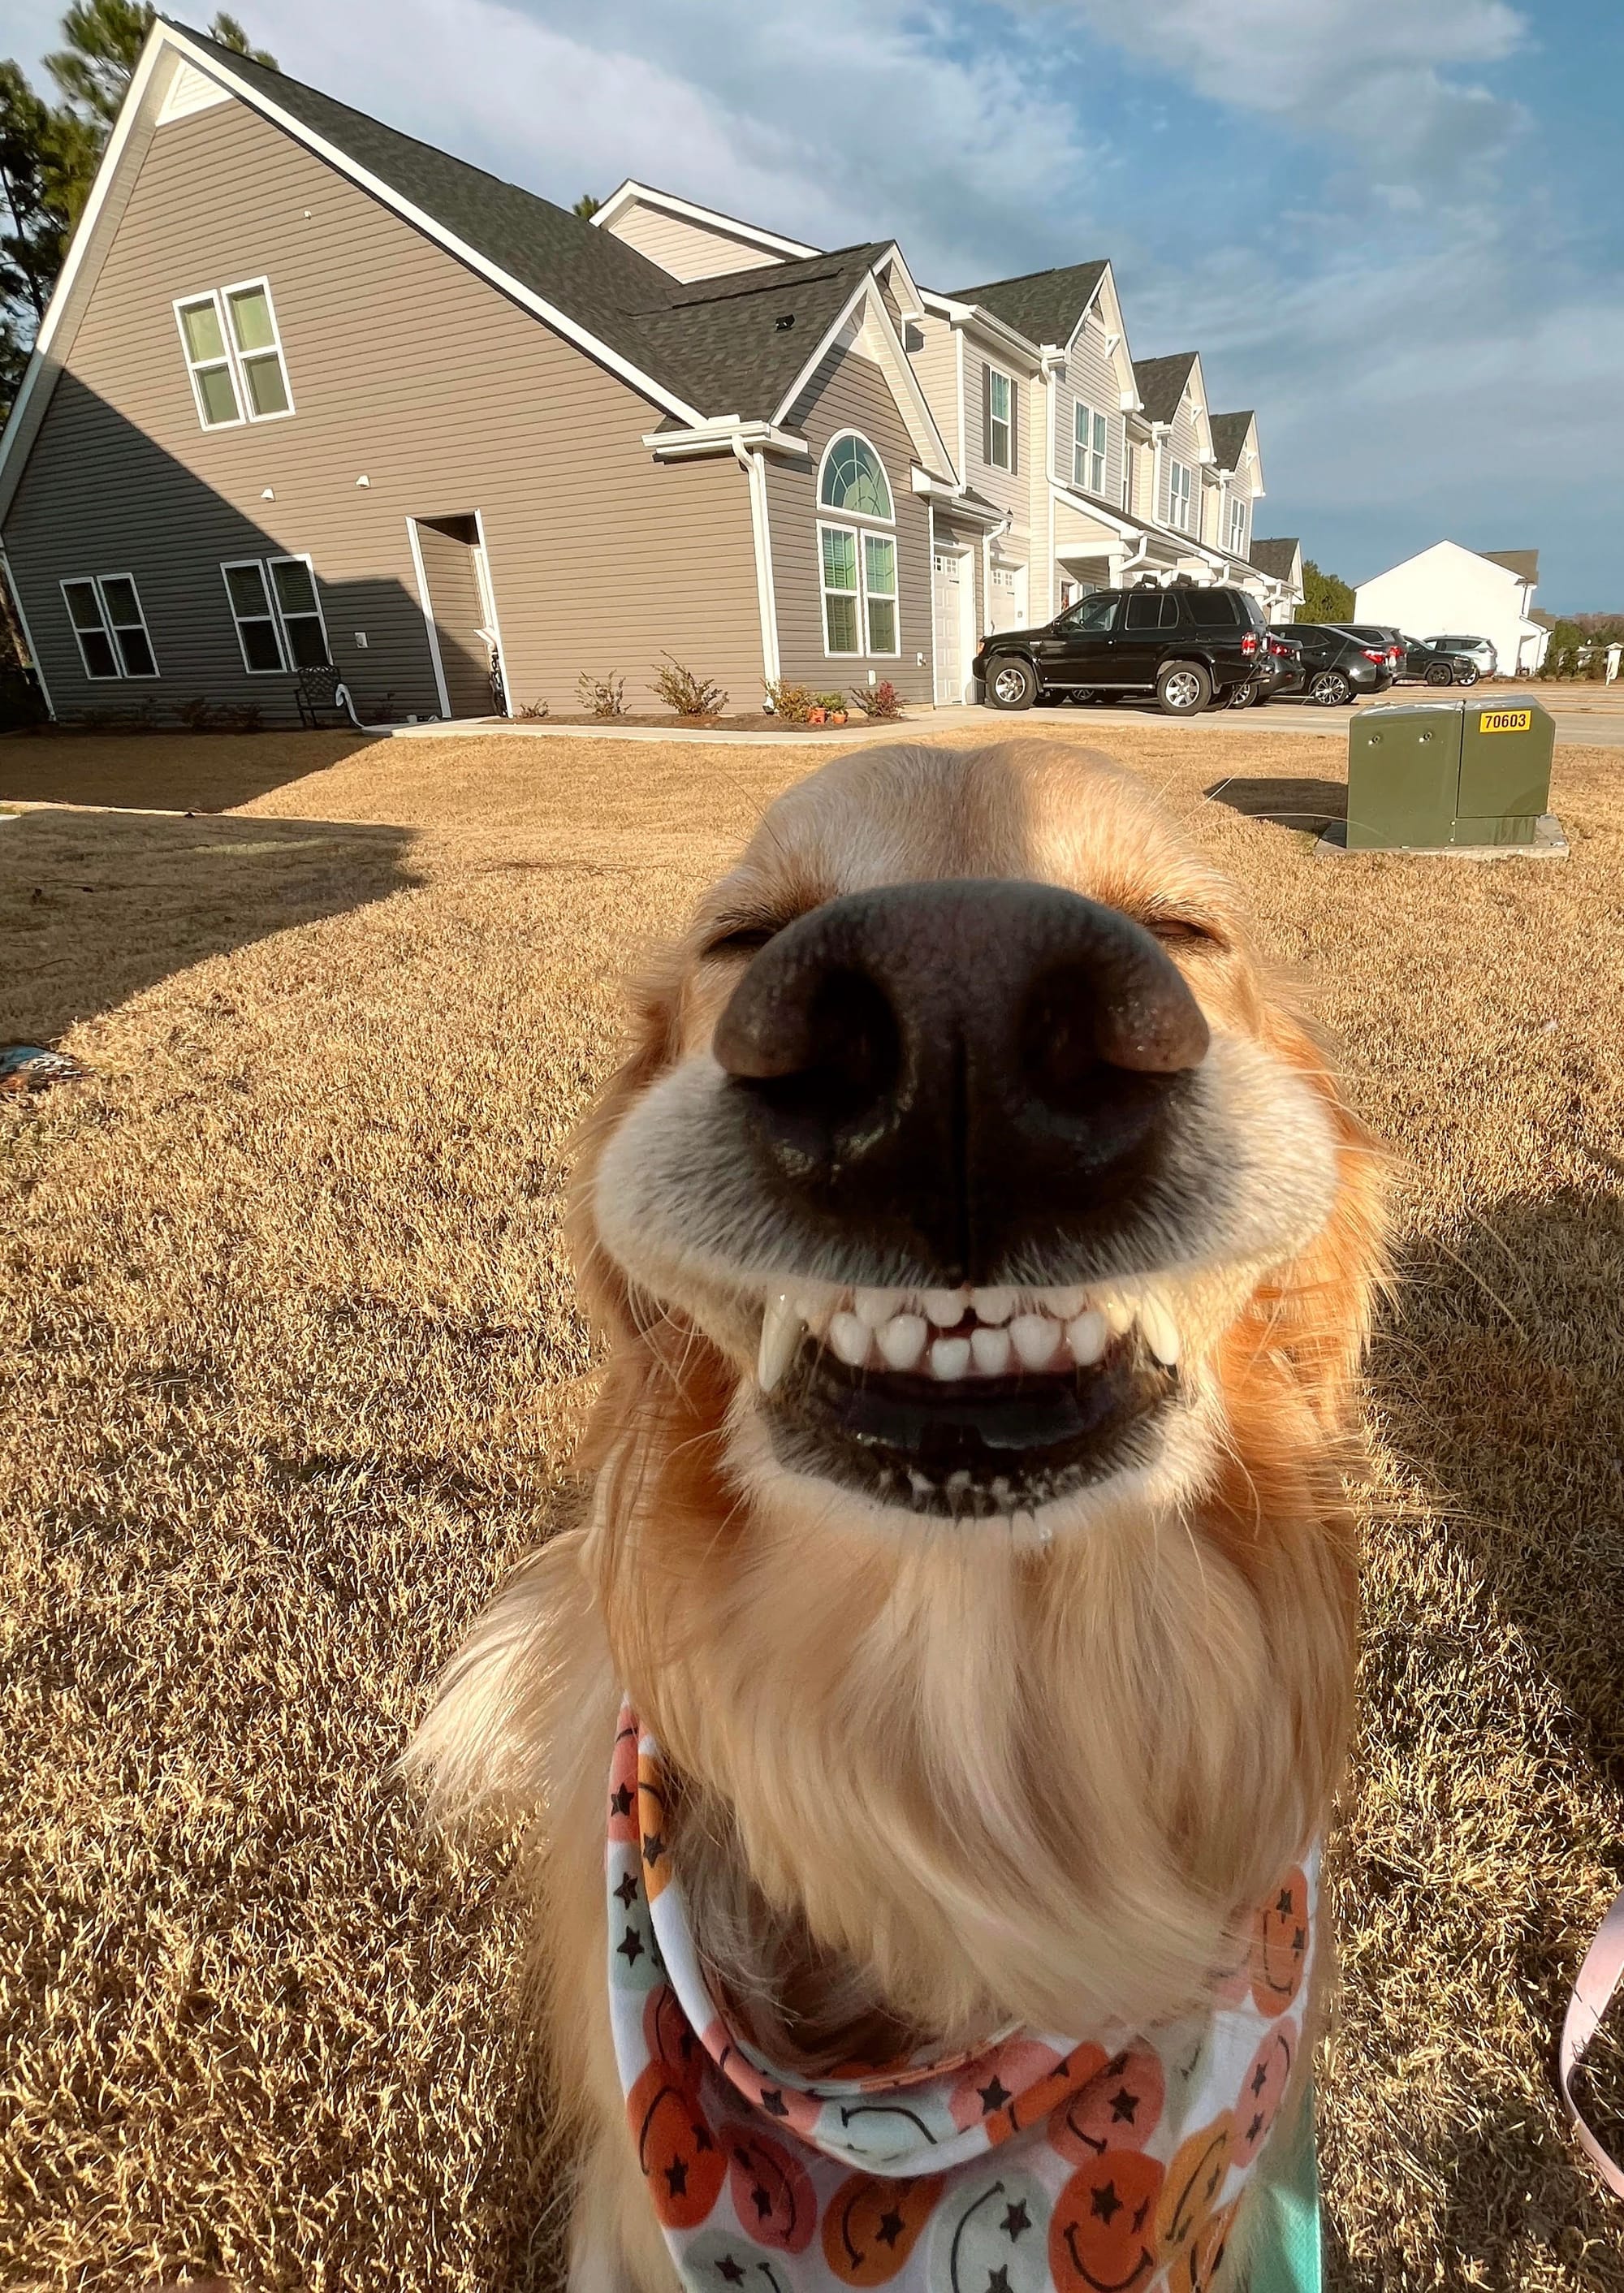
[970, 587, 1268, 715]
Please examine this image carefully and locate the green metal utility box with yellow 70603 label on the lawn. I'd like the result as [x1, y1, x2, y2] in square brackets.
[1346, 702, 1555, 853]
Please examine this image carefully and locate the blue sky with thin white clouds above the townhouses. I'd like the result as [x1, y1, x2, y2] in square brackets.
[6, 0, 1624, 610]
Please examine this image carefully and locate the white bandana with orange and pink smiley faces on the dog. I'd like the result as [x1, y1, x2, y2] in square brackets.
[608, 1708, 1319, 2293]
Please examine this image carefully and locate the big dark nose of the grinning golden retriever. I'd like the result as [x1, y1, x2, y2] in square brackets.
[714, 880, 1207, 1282]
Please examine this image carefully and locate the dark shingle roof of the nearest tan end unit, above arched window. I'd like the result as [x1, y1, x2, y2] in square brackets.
[166, 25, 890, 420]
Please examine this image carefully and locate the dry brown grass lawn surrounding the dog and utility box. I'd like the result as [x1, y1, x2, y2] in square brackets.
[0, 718, 1624, 2293]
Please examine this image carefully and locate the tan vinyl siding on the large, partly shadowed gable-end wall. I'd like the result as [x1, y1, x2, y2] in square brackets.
[5, 101, 762, 723]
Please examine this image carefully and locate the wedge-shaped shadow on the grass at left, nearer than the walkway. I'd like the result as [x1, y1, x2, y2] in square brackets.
[0, 797, 417, 1043]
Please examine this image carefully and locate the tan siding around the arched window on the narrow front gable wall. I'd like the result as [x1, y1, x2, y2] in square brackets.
[767, 348, 931, 706]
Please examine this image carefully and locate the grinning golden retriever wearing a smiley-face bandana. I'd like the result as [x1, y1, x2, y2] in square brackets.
[411, 741, 1383, 2293]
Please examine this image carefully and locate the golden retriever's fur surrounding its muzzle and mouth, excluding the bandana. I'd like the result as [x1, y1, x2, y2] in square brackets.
[412, 743, 1381, 2293]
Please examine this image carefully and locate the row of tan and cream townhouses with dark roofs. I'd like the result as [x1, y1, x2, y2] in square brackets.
[0, 19, 1302, 723]
